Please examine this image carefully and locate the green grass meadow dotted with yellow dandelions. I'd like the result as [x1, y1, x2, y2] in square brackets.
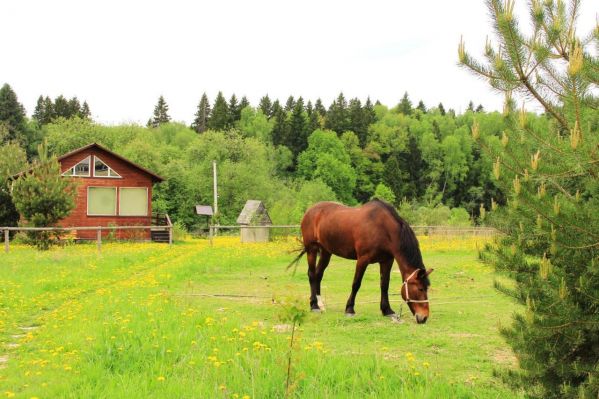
[0, 237, 520, 399]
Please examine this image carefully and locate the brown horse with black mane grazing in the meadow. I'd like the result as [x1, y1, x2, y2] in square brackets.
[290, 199, 433, 323]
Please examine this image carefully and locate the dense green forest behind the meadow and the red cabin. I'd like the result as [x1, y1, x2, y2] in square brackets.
[0, 84, 536, 229]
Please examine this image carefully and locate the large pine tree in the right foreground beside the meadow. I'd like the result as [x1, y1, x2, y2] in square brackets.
[459, 0, 599, 398]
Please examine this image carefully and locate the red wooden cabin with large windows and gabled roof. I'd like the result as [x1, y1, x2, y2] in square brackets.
[58, 143, 164, 240]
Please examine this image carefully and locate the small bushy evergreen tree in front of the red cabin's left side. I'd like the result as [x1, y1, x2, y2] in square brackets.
[11, 144, 76, 250]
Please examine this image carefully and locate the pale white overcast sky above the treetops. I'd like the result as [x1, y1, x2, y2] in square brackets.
[0, 0, 599, 124]
